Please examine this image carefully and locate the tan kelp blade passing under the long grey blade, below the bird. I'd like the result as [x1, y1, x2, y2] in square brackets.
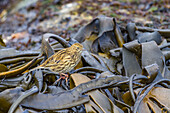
[71, 73, 122, 112]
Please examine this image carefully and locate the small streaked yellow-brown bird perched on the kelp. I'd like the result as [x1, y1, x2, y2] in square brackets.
[38, 43, 83, 81]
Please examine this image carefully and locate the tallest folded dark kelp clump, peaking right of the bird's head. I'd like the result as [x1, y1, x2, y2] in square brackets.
[73, 16, 124, 53]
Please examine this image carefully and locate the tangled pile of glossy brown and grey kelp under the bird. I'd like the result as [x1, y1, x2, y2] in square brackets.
[0, 16, 170, 113]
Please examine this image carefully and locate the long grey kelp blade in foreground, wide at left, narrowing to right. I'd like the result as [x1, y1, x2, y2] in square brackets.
[21, 73, 128, 110]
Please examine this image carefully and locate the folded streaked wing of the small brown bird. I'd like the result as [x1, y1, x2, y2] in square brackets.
[41, 49, 67, 67]
